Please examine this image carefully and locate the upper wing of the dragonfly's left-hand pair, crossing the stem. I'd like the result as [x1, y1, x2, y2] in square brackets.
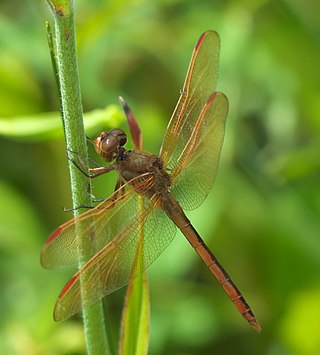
[41, 177, 151, 268]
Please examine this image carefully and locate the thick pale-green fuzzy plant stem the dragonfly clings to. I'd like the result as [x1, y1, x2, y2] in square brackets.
[47, 0, 108, 355]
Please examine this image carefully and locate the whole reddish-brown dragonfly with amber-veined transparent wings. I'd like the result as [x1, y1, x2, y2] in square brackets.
[41, 30, 261, 332]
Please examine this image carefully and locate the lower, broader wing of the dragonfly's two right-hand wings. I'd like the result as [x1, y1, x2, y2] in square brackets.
[172, 92, 228, 210]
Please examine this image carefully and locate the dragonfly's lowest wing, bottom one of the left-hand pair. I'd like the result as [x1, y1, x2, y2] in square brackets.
[54, 195, 176, 321]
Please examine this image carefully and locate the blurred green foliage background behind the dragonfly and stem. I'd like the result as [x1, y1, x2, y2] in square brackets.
[0, 0, 320, 355]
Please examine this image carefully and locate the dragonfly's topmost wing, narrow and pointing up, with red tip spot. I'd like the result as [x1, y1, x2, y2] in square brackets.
[160, 31, 220, 170]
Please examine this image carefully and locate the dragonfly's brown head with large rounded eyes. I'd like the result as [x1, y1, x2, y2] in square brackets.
[94, 128, 127, 161]
